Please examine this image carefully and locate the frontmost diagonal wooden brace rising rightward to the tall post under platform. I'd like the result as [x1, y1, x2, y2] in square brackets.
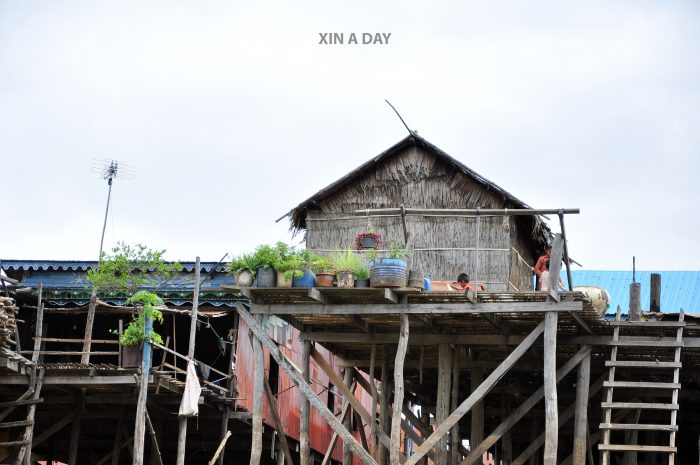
[406, 322, 544, 465]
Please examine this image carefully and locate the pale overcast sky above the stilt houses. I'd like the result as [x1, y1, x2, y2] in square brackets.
[0, 0, 700, 269]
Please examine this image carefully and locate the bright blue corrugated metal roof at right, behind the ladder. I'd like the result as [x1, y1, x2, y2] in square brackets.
[562, 270, 700, 313]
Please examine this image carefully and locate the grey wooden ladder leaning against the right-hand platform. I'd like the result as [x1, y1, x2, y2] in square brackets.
[598, 306, 685, 465]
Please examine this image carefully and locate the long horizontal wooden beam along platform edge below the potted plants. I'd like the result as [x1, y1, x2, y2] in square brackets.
[251, 300, 583, 316]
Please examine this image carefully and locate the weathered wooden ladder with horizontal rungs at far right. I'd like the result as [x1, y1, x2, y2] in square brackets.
[598, 307, 685, 465]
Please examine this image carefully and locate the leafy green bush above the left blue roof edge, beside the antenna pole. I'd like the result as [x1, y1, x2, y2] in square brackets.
[87, 242, 182, 294]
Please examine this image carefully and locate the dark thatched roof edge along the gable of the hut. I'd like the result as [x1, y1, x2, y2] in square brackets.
[282, 133, 551, 245]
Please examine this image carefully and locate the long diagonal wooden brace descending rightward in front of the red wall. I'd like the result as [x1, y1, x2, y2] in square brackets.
[236, 302, 376, 465]
